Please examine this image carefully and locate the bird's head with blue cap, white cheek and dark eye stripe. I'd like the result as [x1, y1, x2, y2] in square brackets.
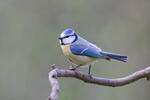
[58, 28, 78, 45]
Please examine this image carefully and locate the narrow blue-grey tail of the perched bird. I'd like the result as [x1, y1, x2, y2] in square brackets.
[101, 51, 128, 62]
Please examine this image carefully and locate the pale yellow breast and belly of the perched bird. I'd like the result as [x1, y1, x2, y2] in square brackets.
[61, 44, 98, 65]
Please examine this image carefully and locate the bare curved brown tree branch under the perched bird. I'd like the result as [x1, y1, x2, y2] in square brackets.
[48, 65, 150, 100]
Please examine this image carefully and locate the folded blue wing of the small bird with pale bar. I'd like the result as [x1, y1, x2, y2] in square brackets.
[70, 44, 104, 58]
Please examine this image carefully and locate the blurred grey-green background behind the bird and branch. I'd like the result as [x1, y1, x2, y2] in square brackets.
[0, 0, 150, 100]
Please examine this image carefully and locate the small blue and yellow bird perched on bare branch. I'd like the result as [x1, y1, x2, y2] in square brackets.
[58, 28, 128, 75]
